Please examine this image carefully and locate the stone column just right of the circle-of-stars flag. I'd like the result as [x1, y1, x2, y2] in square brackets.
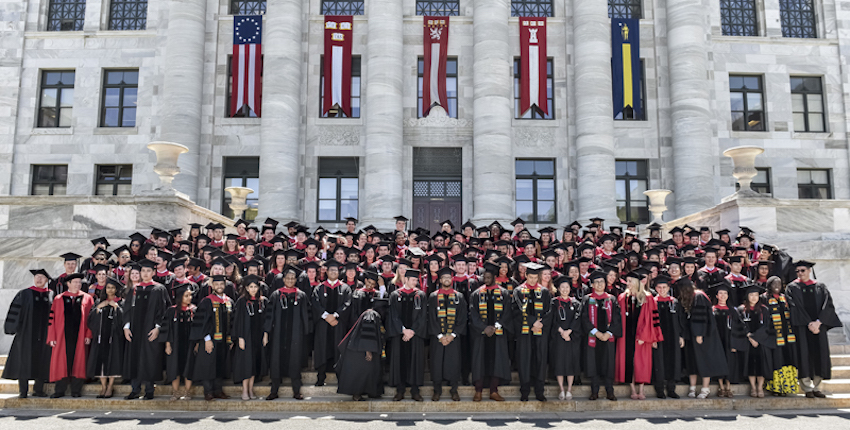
[258, 0, 304, 220]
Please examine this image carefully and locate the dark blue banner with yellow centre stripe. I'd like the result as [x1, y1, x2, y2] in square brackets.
[611, 19, 643, 119]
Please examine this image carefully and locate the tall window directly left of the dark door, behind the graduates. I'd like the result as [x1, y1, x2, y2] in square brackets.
[317, 157, 360, 222]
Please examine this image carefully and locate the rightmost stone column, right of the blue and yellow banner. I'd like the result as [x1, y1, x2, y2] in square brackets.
[667, 0, 717, 218]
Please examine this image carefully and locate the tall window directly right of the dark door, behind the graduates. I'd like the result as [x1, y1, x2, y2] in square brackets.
[516, 159, 557, 223]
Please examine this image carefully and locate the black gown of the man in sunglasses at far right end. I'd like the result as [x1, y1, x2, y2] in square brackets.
[785, 281, 842, 379]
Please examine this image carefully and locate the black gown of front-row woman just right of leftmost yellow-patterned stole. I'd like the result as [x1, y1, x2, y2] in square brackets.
[233, 296, 268, 384]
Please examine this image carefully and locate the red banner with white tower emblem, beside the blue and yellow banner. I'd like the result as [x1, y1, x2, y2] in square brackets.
[519, 17, 549, 115]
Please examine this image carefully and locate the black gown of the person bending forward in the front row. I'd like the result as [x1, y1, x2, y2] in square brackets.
[336, 309, 384, 397]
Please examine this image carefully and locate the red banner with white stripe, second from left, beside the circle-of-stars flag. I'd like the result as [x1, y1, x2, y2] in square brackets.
[322, 16, 354, 116]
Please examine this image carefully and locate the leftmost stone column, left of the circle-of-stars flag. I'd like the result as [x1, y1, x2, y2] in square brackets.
[159, 0, 207, 201]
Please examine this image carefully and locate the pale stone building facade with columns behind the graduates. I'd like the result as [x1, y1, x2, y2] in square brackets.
[0, 0, 850, 232]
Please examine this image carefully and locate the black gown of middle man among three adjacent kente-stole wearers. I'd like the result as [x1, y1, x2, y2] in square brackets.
[468, 286, 514, 383]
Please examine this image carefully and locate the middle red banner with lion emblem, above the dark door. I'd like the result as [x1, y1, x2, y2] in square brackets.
[422, 16, 449, 117]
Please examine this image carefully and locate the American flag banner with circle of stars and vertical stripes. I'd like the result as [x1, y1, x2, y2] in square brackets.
[230, 15, 263, 117]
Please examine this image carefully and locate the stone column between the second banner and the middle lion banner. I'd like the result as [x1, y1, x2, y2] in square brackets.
[354, 0, 404, 228]
